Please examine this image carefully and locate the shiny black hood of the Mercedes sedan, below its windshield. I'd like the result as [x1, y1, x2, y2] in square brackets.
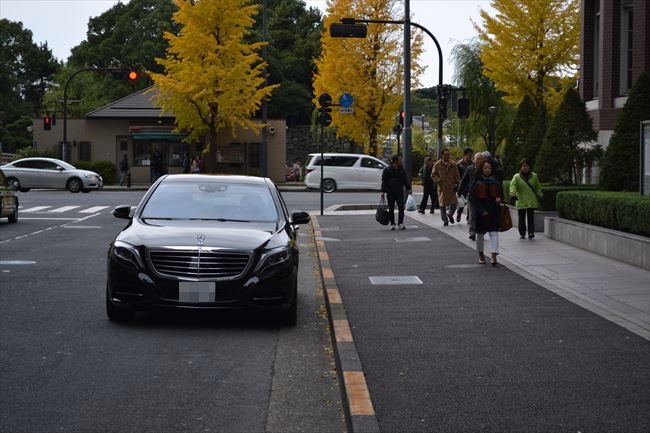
[116, 219, 277, 251]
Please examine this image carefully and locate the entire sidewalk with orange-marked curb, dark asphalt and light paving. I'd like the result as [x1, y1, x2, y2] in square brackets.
[312, 206, 650, 433]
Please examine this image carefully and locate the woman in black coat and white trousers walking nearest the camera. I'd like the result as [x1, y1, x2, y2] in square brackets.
[469, 160, 503, 266]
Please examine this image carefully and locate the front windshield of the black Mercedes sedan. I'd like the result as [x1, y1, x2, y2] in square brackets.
[140, 181, 278, 222]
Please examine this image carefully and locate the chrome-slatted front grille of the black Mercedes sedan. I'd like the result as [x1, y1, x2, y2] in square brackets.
[149, 248, 251, 279]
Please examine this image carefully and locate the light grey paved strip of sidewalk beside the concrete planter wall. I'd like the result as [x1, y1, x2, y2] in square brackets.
[318, 206, 650, 340]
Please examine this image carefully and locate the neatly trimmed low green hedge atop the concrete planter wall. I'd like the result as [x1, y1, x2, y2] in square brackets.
[557, 191, 650, 237]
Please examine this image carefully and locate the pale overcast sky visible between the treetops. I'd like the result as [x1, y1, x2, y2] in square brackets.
[0, 0, 492, 87]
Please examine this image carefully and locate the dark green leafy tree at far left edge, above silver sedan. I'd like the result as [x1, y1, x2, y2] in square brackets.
[0, 19, 59, 153]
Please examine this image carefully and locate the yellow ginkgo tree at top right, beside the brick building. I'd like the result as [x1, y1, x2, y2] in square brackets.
[474, 0, 580, 108]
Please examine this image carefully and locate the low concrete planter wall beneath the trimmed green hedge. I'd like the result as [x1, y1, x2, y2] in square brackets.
[544, 217, 650, 271]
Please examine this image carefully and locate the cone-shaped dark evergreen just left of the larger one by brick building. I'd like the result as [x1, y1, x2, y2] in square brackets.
[537, 89, 597, 183]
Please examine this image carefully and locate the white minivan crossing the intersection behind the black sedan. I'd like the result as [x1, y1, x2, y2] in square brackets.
[305, 153, 388, 192]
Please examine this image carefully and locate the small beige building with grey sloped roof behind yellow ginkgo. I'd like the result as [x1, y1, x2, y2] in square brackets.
[33, 89, 286, 184]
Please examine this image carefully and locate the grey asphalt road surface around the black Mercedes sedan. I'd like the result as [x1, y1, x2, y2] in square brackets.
[0, 191, 345, 433]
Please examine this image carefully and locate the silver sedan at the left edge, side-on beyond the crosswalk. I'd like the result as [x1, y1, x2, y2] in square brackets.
[0, 157, 104, 192]
